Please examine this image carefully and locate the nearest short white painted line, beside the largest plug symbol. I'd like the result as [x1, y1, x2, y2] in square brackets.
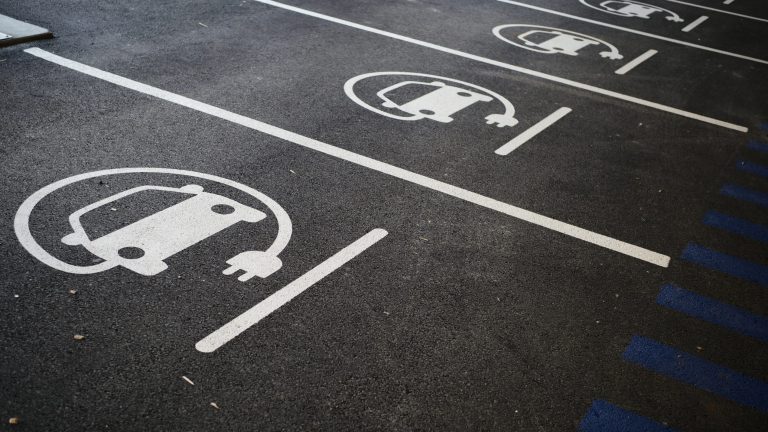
[195, 228, 387, 353]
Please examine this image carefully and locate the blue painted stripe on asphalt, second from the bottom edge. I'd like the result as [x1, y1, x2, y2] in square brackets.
[624, 336, 768, 413]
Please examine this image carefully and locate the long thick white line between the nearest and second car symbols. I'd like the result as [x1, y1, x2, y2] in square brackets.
[24, 48, 669, 267]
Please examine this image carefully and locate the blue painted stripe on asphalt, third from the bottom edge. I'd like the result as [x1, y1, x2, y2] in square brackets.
[656, 284, 768, 342]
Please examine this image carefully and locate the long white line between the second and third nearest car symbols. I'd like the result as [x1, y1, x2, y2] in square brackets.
[254, 0, 752, 132]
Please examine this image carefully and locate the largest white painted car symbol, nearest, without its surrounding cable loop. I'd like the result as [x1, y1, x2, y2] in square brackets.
[62, 185, 266, 276]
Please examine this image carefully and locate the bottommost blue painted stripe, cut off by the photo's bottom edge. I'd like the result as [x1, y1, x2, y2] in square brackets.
[579, 400, 674, 432]
